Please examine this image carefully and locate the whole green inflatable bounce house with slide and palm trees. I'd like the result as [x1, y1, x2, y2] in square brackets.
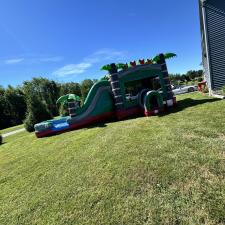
[34, 53, 176, 137]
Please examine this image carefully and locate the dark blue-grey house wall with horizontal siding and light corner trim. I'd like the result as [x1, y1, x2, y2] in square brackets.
[199, 0, 225, 91]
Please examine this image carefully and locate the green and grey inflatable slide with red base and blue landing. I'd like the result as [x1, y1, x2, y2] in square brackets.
[34, 81, 114, 137]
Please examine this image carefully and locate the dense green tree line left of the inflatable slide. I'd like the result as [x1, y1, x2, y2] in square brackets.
[0, 77, 97, 131]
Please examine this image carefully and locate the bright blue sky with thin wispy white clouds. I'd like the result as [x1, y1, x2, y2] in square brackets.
[0, 0, 201, 86]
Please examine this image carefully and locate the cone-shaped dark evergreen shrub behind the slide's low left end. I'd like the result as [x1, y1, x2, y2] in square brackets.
[24, 96, 52, 132]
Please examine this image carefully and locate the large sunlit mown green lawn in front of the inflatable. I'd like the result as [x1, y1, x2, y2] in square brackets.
[0, 93, 225, 225]
